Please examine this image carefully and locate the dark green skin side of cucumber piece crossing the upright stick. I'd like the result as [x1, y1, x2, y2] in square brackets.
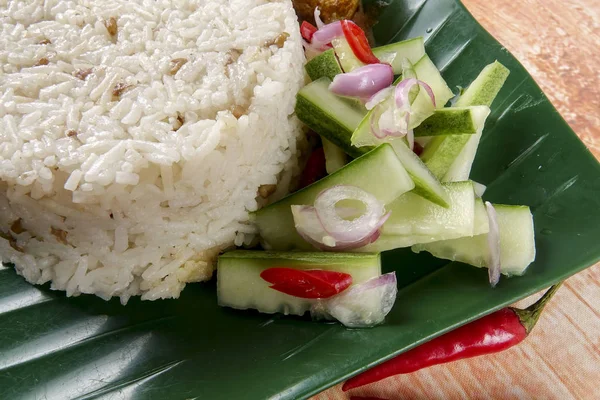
[414, 108, 477, 137]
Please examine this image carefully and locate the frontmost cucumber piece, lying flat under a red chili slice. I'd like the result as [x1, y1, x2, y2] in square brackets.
[217, 250, 381, 315]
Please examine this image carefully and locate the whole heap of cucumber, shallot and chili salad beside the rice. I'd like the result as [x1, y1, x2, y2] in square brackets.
[218, 14, 535, 327]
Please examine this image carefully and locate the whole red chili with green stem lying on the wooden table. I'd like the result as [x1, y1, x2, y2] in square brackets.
[342, 283, 561, 391]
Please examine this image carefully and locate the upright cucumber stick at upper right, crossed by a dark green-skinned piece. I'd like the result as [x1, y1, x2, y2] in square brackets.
[442, 61, 510, 182]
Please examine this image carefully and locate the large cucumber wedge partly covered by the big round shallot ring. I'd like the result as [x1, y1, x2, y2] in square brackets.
[251, 144, 412, 251]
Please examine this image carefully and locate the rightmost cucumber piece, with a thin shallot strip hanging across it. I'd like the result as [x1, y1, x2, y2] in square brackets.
[412, 205, 535, 276]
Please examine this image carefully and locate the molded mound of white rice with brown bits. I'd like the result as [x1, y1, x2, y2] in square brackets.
[0, 0, 304, 303]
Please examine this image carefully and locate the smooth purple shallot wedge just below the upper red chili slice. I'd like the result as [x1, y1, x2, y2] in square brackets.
[329, 64, 394, 99]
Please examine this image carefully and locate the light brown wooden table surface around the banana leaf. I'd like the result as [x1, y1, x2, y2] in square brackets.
[313, 0, 600, 400]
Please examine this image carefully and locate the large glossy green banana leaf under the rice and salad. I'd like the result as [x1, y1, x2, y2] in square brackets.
[0, 0, 600, 400]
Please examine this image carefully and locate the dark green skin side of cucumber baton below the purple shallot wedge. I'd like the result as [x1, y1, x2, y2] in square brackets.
[296, 86, 370, 158]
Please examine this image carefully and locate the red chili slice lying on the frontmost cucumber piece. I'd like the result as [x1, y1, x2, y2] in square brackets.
[260, 267, 352, 299]
